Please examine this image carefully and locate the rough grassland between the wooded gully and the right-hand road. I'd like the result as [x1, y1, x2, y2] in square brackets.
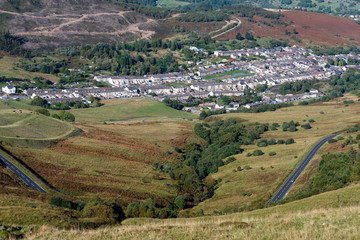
[194, 95, 360, 214]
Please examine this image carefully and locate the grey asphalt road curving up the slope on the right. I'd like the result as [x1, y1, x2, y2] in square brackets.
[269, 133, 342, 204]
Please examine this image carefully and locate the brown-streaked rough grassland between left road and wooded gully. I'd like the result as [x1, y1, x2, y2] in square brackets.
[3, 120, 194, 205]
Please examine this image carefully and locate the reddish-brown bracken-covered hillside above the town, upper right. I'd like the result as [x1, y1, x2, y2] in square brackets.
[218, 10, 360, 46]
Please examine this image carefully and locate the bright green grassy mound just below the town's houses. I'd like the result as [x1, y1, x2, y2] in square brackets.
[71, 98, 197, 123]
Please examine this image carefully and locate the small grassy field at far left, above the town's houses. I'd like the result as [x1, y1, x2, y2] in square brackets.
[0, 56, 59, 82]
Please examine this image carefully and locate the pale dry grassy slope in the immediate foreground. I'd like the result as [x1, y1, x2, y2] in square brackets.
[28, 184, 360, 239]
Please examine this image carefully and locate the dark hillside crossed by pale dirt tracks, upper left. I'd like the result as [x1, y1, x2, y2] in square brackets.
[0, 0, 155, 49]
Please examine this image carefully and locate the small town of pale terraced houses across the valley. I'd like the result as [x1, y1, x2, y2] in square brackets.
[1, 45, 360, 113]
